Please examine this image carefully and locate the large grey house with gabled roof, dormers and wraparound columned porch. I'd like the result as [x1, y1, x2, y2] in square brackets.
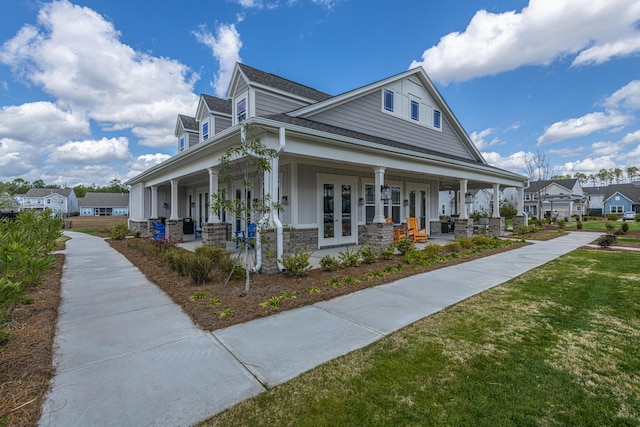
[126, 63, 527, 271]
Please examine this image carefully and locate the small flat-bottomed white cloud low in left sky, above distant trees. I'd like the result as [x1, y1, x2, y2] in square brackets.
[49, 137, 130, 164]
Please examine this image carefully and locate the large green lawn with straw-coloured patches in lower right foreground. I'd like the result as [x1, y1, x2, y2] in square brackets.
[203, 250, 640, 427]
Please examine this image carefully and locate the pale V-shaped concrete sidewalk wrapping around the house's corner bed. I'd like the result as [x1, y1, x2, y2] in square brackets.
[40, 233, 600, 426]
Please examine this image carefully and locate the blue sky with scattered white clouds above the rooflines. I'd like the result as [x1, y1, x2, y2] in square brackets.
[0, 0, 640, 186]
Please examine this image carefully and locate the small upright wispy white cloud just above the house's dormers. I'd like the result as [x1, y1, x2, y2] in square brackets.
[194, 24, 242, 97]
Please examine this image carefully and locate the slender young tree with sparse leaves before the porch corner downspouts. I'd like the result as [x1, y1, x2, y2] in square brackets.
[211, 125, 282, 296]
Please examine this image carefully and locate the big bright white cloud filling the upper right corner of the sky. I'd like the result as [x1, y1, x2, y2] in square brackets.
[410, 0, 640, 84]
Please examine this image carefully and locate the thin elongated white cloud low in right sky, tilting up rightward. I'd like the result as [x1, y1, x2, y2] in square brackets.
[537, 111, 634, 146]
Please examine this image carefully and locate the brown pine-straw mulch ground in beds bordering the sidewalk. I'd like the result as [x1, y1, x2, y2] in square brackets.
[0, 226, 640, 427]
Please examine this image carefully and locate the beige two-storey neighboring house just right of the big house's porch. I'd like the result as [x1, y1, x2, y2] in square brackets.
[524, 179, 585, 219]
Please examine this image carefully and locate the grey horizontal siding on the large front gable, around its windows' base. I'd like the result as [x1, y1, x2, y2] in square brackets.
[307, 90, 476, 160]
